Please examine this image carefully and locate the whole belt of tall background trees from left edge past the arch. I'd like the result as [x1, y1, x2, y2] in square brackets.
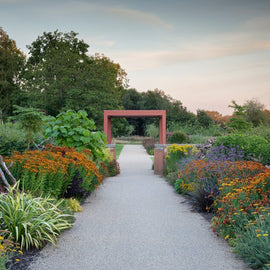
[0, 27, 270, 135]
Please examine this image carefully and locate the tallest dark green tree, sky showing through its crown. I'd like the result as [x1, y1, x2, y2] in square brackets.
[21, 30, 89, 115]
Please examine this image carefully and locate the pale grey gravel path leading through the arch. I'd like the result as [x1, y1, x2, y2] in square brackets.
[30, 145, 248, 270]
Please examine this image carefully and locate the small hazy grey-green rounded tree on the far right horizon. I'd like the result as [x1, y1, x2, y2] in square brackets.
[244, 99, 268, 127]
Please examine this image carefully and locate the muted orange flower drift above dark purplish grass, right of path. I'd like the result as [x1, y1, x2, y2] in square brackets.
[175, 160, 264, 211]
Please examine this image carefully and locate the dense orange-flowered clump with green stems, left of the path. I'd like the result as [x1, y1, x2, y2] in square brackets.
[6, 145, 103, 199]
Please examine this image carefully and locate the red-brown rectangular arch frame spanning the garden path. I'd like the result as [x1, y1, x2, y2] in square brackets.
[104, 110, 166, 144]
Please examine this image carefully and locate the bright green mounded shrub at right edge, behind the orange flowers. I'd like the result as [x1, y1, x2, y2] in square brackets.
[214, 134, 270, 164]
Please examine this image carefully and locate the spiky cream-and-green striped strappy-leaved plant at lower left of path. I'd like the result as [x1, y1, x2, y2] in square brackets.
[0, 186, 72, 250]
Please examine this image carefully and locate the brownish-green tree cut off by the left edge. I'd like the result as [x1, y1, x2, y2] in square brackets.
[0, 27, 25, 121]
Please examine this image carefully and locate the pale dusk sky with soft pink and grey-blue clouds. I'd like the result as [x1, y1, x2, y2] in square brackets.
[0, 0, 270, 115]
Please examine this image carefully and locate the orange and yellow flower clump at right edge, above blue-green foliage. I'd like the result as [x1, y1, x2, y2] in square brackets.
[213, 168, 270, 238]
